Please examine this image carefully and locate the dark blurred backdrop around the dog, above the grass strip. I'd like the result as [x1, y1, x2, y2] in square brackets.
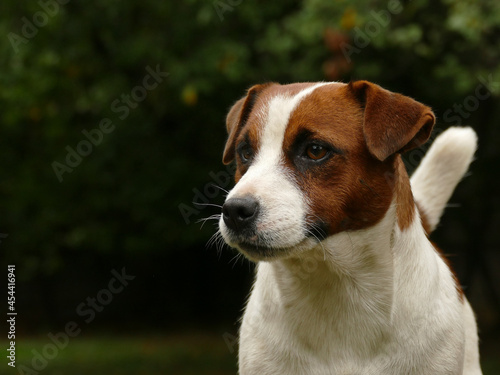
[0, 0, 500, 374]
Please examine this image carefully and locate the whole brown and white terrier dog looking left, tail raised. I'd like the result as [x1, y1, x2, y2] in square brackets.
[219, 81, 481, 375]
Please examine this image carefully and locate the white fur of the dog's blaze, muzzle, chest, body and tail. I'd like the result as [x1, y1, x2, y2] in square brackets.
[220, 86, 481, 375]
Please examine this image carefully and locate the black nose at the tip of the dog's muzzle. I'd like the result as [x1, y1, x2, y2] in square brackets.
[222, 197, 259, 232]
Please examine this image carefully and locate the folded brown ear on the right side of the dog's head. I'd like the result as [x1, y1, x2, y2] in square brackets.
[349, 81, 436, 161]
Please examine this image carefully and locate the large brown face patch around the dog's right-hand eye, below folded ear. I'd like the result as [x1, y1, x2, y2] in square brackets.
[283, 85, 393, 235]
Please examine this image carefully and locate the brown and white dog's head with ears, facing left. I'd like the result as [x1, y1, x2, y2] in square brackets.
[219, 81, 435, 260]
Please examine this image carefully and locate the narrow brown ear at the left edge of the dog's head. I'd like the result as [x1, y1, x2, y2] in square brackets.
[222, 83, 271, 164]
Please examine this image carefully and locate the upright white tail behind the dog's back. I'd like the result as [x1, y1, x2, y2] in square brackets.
[411, 127, 477, 234]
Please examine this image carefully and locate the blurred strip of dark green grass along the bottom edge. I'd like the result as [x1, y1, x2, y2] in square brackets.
[6, 334, 500, 375]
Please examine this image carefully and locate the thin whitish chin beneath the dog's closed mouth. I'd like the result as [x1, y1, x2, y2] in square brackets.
[230, 238, 314, 262]
